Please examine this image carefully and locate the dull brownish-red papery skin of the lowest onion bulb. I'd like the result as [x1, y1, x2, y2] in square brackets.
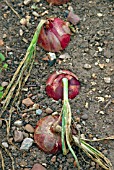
[34, 115, 62, 154]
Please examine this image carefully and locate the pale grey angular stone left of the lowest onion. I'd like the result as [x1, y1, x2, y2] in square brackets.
[20, 138, 34, 151]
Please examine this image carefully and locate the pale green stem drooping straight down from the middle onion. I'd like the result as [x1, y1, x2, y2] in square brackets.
[61, 78, 80, 170]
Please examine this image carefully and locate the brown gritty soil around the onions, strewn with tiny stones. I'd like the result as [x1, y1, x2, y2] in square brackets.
[0, 0, 114, 170]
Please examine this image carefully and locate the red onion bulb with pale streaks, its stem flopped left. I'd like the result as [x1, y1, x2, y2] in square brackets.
[38, 18, 70, 52]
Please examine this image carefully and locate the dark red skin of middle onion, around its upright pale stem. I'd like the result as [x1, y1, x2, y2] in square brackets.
[46, 70, 80, 100]
